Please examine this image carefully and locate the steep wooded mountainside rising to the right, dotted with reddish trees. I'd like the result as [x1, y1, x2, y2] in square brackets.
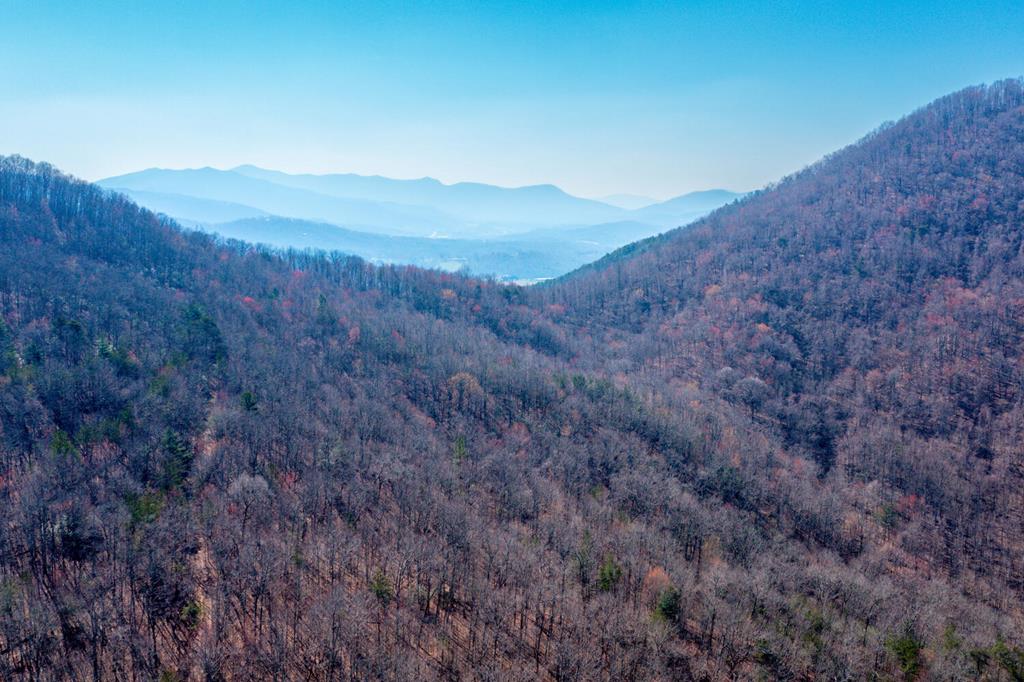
[541, 81, 1024, 608]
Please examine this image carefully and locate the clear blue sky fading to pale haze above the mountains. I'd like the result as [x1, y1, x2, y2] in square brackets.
[0, 0, 1024, 198]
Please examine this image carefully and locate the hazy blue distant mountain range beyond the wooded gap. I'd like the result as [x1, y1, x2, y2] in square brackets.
[98, 166, 741, 281]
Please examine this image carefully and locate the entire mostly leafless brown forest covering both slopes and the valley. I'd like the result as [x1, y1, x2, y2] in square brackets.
[0, 81, 1024, 681]
